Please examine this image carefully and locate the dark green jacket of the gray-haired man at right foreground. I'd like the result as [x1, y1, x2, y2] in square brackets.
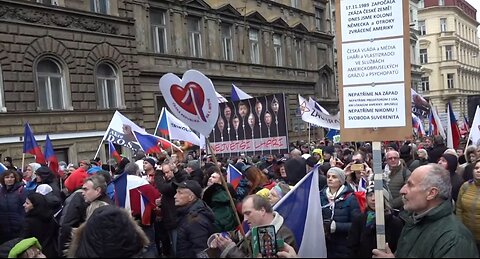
[395, 201, 478, 258]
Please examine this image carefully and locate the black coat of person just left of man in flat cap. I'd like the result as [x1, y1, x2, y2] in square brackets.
[155, 172, 188, 230]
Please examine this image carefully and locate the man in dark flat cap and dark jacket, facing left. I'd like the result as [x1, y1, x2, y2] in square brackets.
[172, 180, 215, 258]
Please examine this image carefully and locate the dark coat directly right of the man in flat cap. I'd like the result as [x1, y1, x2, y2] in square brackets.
[202, 183, 238, 232]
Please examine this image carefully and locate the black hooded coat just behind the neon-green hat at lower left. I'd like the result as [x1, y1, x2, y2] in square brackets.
[20, 194, 58, 258]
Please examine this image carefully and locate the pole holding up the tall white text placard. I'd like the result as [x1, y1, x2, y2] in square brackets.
[372, 141, 386, 251]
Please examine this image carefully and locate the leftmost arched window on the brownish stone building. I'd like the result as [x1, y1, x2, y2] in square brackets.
[36, 58, 68, 110]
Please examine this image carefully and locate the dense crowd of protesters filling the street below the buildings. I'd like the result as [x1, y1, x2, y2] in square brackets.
[0, 136, 480, 258]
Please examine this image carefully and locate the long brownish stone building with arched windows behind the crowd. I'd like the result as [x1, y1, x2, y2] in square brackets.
[0, 0, 338, 165]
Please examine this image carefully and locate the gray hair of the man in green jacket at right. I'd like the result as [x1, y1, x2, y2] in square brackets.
[420, 163, 452, 200]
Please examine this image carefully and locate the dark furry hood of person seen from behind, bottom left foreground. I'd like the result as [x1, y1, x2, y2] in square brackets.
[66, 205, 149, 258]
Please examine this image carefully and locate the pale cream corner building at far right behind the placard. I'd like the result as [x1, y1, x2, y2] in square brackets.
[418, 1, 480, 116]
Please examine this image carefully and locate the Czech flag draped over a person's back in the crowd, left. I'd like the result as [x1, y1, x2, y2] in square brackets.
[113, 173, 160, 226]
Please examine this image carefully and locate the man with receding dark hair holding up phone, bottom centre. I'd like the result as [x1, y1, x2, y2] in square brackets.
[209, 194, 297, 258]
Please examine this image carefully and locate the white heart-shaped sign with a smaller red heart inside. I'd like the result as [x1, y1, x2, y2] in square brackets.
[159, 70, 218, 136]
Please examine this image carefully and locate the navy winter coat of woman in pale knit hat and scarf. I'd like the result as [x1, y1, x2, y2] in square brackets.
[320, 185, 360, 258]
